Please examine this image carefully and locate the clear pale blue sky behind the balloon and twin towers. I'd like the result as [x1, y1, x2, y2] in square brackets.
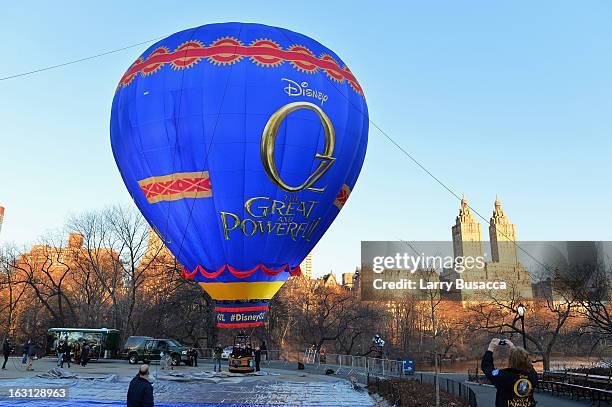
[0, 1, 612, 274]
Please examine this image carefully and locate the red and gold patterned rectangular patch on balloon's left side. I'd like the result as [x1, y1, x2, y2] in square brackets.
[138, 171, 212, 204]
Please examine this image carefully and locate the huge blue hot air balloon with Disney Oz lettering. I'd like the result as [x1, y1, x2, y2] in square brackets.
[110, 23, 368, 327]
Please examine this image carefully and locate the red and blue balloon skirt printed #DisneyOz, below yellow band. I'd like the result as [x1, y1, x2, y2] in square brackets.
[215, 301, 269, 328]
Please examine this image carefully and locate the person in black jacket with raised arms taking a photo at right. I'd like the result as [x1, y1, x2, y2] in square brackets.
[481, 338, 538, 407]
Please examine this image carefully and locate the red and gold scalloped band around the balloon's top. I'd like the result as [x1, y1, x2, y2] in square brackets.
[117, 37, 363, 96]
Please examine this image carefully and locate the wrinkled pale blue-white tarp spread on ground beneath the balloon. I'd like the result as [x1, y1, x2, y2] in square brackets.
[0, 368, 374, 407]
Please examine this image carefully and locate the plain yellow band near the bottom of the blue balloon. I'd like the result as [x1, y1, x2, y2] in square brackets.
[200, 281, 284, 300]
